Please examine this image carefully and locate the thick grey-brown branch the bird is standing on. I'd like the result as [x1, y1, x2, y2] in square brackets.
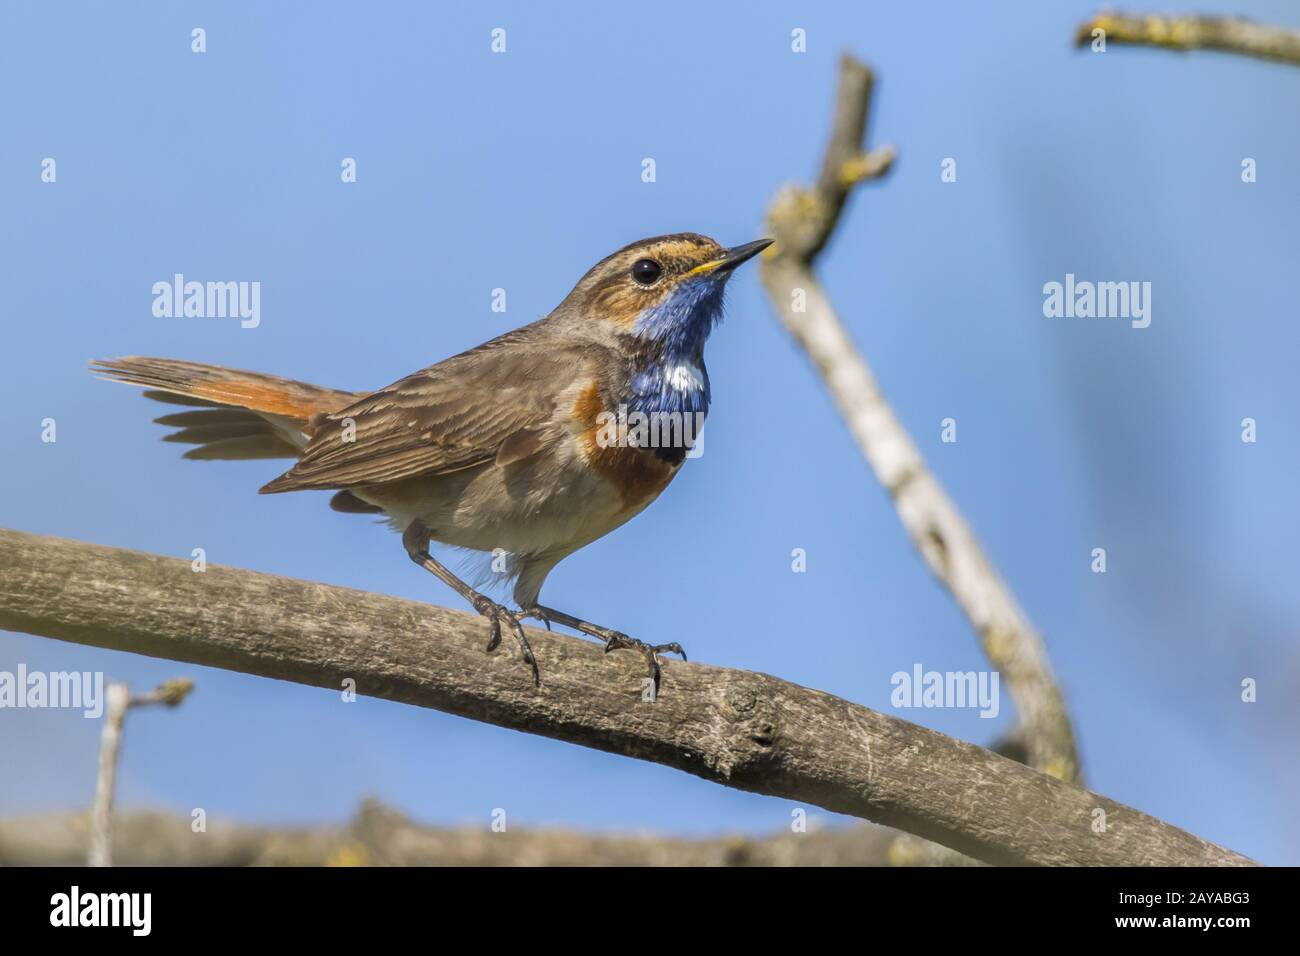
[0, 531, 1249, 865]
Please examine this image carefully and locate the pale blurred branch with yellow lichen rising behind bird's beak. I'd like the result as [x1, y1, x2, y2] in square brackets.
[762, 56, 1079, 780]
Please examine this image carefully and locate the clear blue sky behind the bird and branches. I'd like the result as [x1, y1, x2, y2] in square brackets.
[0, 1, 1300, 864]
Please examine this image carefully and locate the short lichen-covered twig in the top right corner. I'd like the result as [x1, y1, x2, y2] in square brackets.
[1074, 13, 1300, 66]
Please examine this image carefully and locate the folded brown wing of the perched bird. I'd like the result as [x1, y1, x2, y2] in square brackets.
[261, 325, 582, 494]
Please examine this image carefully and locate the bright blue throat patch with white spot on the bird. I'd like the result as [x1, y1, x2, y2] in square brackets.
[628, 276, 725, 415]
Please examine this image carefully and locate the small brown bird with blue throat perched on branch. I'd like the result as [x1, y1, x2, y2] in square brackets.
[92, 233, 771, 688]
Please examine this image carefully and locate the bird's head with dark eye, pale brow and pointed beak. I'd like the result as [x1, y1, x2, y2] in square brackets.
[566, 233, 772, 355]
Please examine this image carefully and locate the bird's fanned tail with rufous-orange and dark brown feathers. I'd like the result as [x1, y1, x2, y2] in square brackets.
[91, 355, 361, 460]
